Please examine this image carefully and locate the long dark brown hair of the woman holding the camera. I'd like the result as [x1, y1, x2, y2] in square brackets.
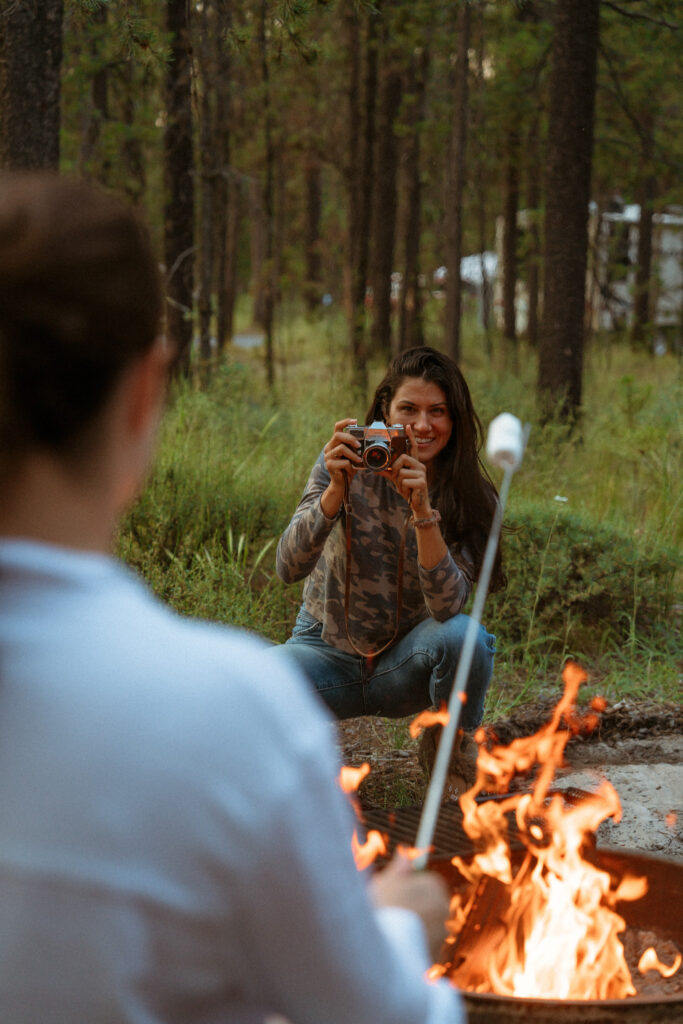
[366, 345, 506, 590]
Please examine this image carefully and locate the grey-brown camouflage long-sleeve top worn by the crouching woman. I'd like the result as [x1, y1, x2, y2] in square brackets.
[276, 454, 474, 653]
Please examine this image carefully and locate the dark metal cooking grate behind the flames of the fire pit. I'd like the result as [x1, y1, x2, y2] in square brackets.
[360, 787, 589, 859]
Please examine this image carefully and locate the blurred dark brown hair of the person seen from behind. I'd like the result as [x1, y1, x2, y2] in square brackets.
[0, 172, 162, 470]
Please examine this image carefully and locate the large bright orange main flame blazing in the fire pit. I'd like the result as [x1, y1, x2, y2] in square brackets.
[431, 664, 680, 999]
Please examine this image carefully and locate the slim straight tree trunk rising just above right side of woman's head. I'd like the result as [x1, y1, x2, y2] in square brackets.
[444, 3, 470, 362]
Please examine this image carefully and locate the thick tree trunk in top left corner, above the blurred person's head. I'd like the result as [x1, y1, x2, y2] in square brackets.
[0, 0, 63, 170]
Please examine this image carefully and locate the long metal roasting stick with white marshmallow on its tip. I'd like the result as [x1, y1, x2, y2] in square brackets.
[413, 413, 529, 870]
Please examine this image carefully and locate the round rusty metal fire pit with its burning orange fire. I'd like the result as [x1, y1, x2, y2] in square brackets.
[352, 666, 683, 1024]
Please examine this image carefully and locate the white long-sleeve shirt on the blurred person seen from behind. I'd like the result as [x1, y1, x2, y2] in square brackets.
[0, 541, 464, 1024]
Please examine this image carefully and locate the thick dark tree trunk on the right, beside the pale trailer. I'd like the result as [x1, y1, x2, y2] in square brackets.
[538, 0, 600, 422]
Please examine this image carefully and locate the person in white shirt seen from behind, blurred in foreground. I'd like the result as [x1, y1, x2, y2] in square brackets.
[0, 174, 464, 1024]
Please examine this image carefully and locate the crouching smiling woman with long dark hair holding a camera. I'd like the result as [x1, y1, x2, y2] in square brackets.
[275, 346, 505, 797]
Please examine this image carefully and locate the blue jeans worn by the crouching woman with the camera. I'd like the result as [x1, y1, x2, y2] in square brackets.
[274, 608, 496, 730]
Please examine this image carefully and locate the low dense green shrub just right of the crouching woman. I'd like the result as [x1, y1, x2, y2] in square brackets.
[486, 504, 681, 656]
